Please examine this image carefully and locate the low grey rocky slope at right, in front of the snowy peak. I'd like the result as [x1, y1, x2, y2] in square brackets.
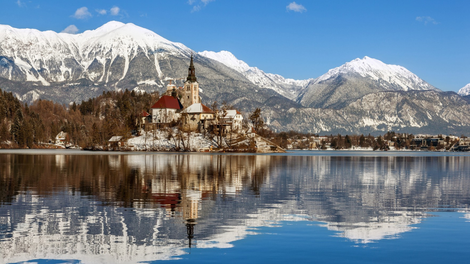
[269, 91, 470, 136]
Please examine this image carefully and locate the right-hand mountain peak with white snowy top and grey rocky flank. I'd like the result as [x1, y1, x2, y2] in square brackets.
[298, 56, 440, 109]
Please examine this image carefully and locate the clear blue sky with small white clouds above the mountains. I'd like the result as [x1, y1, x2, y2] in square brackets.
[0, 0, 470, 91]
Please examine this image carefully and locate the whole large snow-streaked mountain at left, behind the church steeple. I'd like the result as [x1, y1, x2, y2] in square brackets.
[0, 21, 288, 105]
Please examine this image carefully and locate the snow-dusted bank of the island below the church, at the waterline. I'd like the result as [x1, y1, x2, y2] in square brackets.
[127, 130, 217, 151]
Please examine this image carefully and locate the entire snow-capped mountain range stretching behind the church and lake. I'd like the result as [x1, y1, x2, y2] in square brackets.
[0, 21, 470, 134]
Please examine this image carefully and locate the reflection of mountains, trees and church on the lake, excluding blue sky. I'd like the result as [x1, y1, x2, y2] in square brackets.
[0, 154, 470, 262]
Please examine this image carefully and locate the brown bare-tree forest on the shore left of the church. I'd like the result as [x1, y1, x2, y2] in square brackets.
[0, 90, 159, 148]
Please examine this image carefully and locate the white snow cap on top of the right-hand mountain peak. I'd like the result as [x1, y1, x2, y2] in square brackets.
[315, 56, 438, 91]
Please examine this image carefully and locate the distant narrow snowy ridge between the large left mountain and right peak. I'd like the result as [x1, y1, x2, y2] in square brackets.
[199, 50, 312, 100]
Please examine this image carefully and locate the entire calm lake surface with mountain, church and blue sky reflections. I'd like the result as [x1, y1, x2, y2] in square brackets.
[0, 151, 470, 263]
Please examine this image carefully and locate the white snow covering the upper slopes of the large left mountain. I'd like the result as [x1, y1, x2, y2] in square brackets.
[0, 21, 192, 86]
